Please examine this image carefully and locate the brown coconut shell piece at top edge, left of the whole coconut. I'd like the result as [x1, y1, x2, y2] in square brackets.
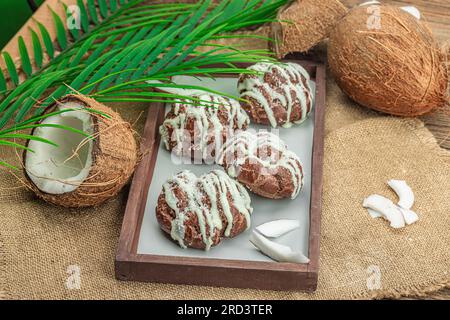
[271, 0, 347, 59]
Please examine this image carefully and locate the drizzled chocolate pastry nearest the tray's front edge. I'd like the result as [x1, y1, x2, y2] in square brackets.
[156, 170, 253, 250]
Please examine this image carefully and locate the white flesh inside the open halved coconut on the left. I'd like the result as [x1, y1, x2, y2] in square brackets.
[25, 102, 94, 194]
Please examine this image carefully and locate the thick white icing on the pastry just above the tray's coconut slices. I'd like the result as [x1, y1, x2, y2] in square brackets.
[218, 131, 304, 199]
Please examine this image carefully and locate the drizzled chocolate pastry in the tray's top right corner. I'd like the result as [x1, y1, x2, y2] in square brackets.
[238, 62, 313, 128]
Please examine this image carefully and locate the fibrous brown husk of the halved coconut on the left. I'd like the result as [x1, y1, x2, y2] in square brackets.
[24, 95, 138, 208]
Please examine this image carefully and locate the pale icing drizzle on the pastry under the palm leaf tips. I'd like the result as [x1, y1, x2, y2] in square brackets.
[159, 93, 250, 159]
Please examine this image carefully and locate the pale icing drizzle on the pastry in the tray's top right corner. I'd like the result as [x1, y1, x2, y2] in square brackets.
[238, 62, 313, 128]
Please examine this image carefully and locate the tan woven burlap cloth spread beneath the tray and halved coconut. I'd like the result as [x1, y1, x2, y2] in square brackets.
[0, 31, 450, 299]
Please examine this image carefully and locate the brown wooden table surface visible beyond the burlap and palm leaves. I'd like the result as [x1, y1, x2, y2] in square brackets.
[0, 0, 450, 299]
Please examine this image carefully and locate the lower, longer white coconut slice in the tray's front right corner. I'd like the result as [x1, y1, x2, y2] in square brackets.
[250, 231, 309, 263]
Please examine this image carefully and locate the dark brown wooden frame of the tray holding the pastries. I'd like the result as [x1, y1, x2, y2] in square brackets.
[115, 60, 326, 291]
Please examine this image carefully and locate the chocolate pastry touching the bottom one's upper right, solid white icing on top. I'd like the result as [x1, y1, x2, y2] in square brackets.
[218, 131, 303, 199]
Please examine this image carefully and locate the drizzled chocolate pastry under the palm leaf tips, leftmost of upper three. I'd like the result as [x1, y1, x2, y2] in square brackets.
[160, 93, 250, 163]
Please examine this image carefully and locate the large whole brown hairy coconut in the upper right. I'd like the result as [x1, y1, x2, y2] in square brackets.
[328, 5, 448, 116]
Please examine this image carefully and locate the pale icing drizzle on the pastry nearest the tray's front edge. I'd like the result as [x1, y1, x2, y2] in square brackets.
[163, 170, 253, 250]
